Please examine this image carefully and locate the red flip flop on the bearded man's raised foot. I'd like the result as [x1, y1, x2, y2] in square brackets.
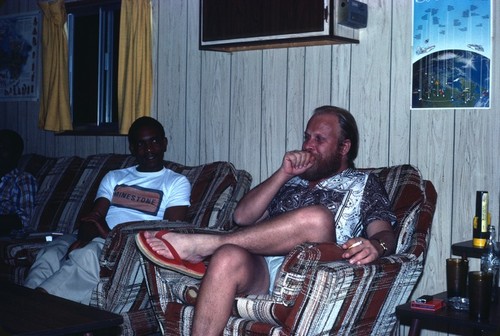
[135, 230, 206, 279]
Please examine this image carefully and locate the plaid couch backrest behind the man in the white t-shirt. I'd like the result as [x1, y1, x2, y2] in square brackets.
[19, 154, 251, 233]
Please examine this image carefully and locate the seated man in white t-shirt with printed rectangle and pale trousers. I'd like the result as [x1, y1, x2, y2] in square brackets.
[25, 117, 191, 304]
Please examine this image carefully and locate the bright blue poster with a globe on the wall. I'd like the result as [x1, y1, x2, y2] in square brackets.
[411, 0, 492, 109]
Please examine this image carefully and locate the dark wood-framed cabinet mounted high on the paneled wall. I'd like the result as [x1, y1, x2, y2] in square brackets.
[200, 0, 359, 52]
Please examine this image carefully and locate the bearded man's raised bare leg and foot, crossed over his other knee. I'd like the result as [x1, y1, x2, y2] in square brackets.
[146, 206, 335, 262]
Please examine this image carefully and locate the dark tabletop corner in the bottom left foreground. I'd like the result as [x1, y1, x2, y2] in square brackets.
[0, 281, 123, 336]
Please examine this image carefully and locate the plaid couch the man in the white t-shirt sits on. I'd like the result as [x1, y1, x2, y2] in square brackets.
[0, 154, 251, 335]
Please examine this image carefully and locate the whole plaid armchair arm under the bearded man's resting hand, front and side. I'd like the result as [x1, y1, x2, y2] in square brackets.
[246, 243, 423, 335]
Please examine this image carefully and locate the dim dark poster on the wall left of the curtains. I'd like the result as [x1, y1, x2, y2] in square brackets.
[0, 12, 41, 101]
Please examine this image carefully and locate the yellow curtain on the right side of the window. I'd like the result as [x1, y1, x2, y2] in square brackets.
[118, 0, 153, 134]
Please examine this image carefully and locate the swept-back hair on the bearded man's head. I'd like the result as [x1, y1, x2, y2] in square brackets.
[313, 105, 359, 168]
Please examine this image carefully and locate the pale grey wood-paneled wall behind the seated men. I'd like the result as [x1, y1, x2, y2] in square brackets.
[0, 0, 500, 334]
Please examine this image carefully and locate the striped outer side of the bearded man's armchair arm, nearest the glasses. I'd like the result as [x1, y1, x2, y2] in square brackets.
[284, 256, 423, 335]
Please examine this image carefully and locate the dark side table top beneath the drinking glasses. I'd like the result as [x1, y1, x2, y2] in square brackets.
[396, 292, 500, 331]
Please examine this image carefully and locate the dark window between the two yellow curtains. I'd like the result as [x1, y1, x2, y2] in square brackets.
[67, 0, 120, 134]
